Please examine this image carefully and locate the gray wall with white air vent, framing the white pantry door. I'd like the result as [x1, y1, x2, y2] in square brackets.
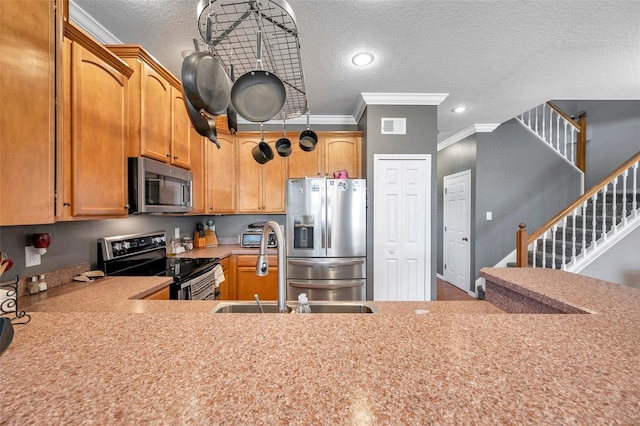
[358, 105, 438, 299]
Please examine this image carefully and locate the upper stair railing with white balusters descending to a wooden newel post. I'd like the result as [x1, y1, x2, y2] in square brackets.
[516, 102, 587, 172]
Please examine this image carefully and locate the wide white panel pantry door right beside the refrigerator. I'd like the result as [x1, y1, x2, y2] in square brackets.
[373, 155, 432, 300]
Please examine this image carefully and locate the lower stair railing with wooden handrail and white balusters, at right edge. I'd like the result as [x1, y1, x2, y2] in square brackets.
[516, 152, 640, 269]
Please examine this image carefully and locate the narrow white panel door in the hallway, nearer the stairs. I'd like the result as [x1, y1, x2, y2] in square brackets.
[443, 170, 471, 292]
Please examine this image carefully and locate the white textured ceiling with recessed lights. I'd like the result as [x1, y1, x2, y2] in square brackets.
[71, 0, 640, 141]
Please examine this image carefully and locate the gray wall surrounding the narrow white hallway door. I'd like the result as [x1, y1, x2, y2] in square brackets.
[437, 134, 477, 280]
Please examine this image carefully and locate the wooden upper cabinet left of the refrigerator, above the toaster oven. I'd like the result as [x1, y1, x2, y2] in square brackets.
[237, 132, 287, 213]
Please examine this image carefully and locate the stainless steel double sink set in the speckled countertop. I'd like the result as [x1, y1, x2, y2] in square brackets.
[211, 301, 378, 314]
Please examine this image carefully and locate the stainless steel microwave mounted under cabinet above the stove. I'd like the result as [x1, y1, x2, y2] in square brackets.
[129, 157, 193, 214]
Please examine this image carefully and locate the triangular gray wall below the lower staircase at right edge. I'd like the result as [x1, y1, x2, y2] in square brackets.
[580, 227, 640, 289]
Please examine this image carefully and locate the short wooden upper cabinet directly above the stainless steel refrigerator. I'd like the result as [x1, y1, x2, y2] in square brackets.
[287, 132, 362, 179]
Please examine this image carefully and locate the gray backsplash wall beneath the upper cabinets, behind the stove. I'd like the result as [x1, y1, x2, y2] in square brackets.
[0, 215, 285, 281]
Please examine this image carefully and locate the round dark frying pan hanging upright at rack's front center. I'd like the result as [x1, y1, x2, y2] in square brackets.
[231, 31, 287, 123]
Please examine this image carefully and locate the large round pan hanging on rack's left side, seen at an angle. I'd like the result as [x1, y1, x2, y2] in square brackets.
[182, 52, 231, 115]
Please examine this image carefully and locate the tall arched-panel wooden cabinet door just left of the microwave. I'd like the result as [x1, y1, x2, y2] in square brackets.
[69, 42, 129, 216]
